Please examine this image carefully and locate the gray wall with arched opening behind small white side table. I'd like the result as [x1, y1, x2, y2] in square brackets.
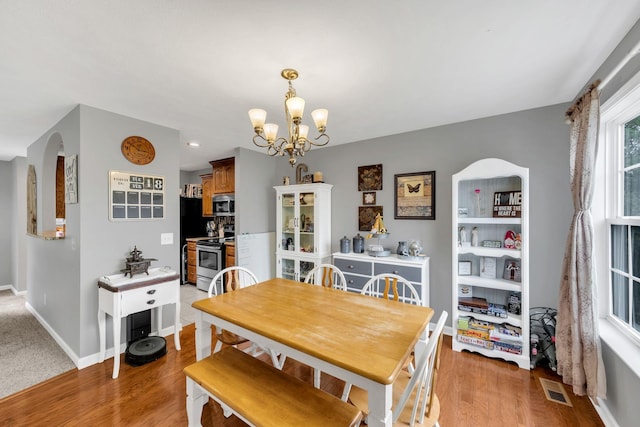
[27, 106, 179, 358]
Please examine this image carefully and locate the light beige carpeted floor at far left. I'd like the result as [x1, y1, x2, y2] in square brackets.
[0, 290, 76, 399]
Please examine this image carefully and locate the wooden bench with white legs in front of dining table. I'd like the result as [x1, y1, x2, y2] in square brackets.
[184, 347, 362, 427]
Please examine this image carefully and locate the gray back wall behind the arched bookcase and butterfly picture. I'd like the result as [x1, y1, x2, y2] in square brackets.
[302, 104, 572, 324]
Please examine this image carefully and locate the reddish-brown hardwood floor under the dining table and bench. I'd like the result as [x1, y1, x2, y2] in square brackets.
[0, 324, 604, 427]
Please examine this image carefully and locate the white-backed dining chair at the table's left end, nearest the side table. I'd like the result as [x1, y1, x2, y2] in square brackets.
[208, 266, 284, 369]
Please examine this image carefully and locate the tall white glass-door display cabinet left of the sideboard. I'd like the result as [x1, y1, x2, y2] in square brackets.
[274, 183, 333, 281]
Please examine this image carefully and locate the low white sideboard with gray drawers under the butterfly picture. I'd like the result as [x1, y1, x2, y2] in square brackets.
[333, 252, 429, 307]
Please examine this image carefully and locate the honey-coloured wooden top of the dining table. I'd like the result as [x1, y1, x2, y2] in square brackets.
[192, 278, 433, 384]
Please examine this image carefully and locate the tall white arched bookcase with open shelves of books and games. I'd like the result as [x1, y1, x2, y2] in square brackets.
[451, 159, 530, 369]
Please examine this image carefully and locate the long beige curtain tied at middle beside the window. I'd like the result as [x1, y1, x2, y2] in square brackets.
[556, 83, 606, 400]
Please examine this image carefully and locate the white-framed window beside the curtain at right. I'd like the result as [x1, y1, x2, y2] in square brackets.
[596, 70, 640, 343]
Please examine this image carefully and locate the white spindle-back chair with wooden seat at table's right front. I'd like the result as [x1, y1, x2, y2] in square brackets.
[349, 311, 449, 427]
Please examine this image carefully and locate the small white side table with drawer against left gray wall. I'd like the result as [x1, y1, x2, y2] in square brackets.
[98, 268, 180, 378]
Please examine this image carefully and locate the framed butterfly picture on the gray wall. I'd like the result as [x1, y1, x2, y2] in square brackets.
[394, 171, 436, 220]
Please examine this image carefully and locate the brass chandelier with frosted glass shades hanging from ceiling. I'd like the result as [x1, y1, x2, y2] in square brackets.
[249, 68, 329, 166]
